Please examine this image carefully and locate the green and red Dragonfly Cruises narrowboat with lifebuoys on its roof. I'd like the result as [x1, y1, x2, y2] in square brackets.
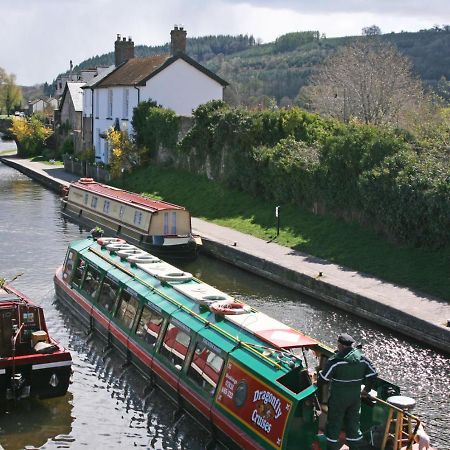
[54, 237, 430, 450]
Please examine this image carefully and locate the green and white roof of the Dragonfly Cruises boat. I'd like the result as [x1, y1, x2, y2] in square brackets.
[71, 239, 319, 360]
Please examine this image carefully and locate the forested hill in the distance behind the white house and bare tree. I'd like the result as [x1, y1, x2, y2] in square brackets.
[69, 25, 450, 106]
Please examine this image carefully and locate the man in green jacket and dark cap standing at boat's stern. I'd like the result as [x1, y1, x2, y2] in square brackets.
[317, 333, 378, 450]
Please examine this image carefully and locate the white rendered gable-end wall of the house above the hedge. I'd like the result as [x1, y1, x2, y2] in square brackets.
[140, 59, 223, 116]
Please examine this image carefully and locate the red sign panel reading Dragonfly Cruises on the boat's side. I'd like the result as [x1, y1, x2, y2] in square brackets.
[217, 360, 292, 448]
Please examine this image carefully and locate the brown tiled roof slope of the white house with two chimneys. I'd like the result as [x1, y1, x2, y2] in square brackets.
[96, 55, 170, 87]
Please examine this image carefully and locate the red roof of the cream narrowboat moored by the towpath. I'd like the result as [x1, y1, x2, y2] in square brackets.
[69, 180, 186, 212]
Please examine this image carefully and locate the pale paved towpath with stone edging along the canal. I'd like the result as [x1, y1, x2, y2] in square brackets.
[0, 156, 450, 353]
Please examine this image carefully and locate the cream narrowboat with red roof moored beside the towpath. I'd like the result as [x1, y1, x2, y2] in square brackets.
[61, 178, 201, 259]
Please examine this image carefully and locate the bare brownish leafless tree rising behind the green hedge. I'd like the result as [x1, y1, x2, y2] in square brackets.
[301, 38, 424, 126]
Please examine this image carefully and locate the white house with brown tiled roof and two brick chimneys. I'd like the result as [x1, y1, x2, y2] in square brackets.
[89, 27, 228, 163]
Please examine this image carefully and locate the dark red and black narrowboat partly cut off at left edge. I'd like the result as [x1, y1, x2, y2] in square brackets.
[0, 279, 72, 405]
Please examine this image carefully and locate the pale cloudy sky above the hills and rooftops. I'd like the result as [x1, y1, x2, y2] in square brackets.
[0, 0, 450, 86]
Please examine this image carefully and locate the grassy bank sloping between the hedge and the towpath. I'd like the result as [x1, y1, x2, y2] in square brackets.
[118, 163, 450, 300]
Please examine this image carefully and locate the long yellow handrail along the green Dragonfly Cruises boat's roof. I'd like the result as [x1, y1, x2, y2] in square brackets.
[89, 247, 282, 369]
